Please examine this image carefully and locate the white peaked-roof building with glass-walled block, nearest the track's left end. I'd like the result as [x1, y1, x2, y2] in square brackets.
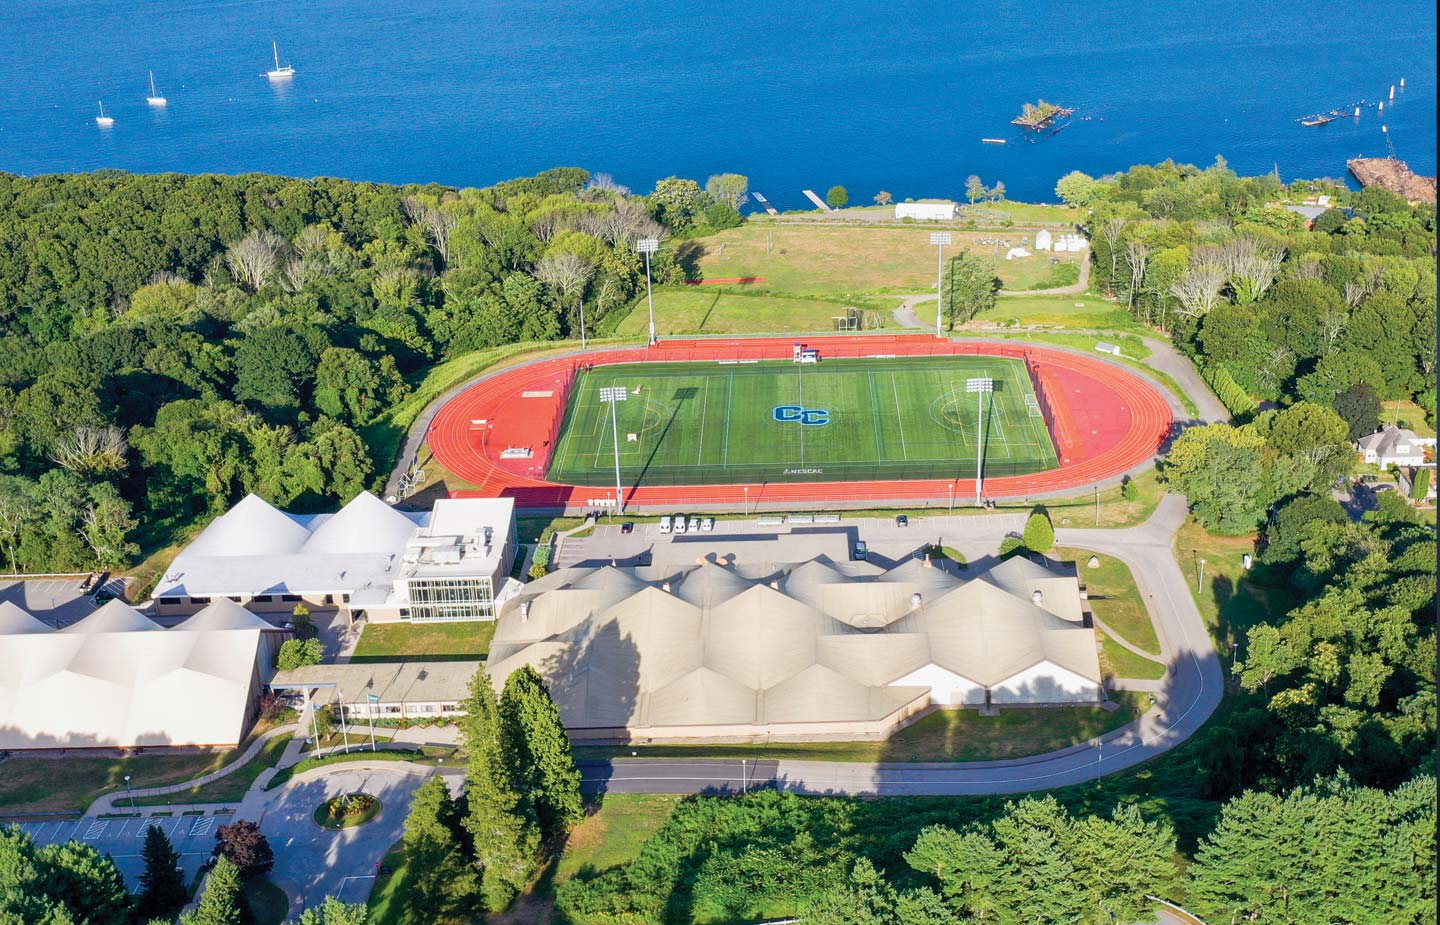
[156, 491, 516, 621]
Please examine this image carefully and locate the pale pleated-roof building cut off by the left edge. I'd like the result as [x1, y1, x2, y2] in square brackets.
[0, 599, 279, 749]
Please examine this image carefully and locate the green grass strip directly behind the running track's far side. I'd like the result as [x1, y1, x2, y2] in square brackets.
[618, 282, 900, 336]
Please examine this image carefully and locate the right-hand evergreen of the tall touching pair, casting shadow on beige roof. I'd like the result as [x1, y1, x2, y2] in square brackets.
[500, 666, 585, 839]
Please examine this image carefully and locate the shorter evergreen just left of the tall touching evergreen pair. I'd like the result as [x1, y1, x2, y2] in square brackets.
[405, 777, 480, 921]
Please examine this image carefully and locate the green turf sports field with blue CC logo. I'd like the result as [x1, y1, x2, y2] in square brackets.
[549, 356, 1057, 486]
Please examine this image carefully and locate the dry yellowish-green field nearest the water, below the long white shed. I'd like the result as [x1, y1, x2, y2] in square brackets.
[681, 222, 1080, 295]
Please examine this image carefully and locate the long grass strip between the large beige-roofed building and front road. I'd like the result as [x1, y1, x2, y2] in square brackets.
[575, 692, 1143, 762]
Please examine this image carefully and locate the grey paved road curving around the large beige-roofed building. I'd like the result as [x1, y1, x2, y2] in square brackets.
[582, 494, 1224, 795]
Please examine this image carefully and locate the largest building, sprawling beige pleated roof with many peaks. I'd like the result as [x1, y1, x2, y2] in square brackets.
[488, 558, 1103, 738]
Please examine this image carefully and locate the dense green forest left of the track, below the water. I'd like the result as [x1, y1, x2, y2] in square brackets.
[0, 169, 744, 572]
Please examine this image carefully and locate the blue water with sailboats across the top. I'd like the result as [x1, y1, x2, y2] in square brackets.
[0, 0, 1436, 207]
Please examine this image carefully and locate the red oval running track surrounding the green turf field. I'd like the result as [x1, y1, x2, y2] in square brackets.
[428, 334, 1172, 510]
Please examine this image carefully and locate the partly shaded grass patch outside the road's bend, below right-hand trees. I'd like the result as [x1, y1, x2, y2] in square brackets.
[1175, 520, 1293, 653]
